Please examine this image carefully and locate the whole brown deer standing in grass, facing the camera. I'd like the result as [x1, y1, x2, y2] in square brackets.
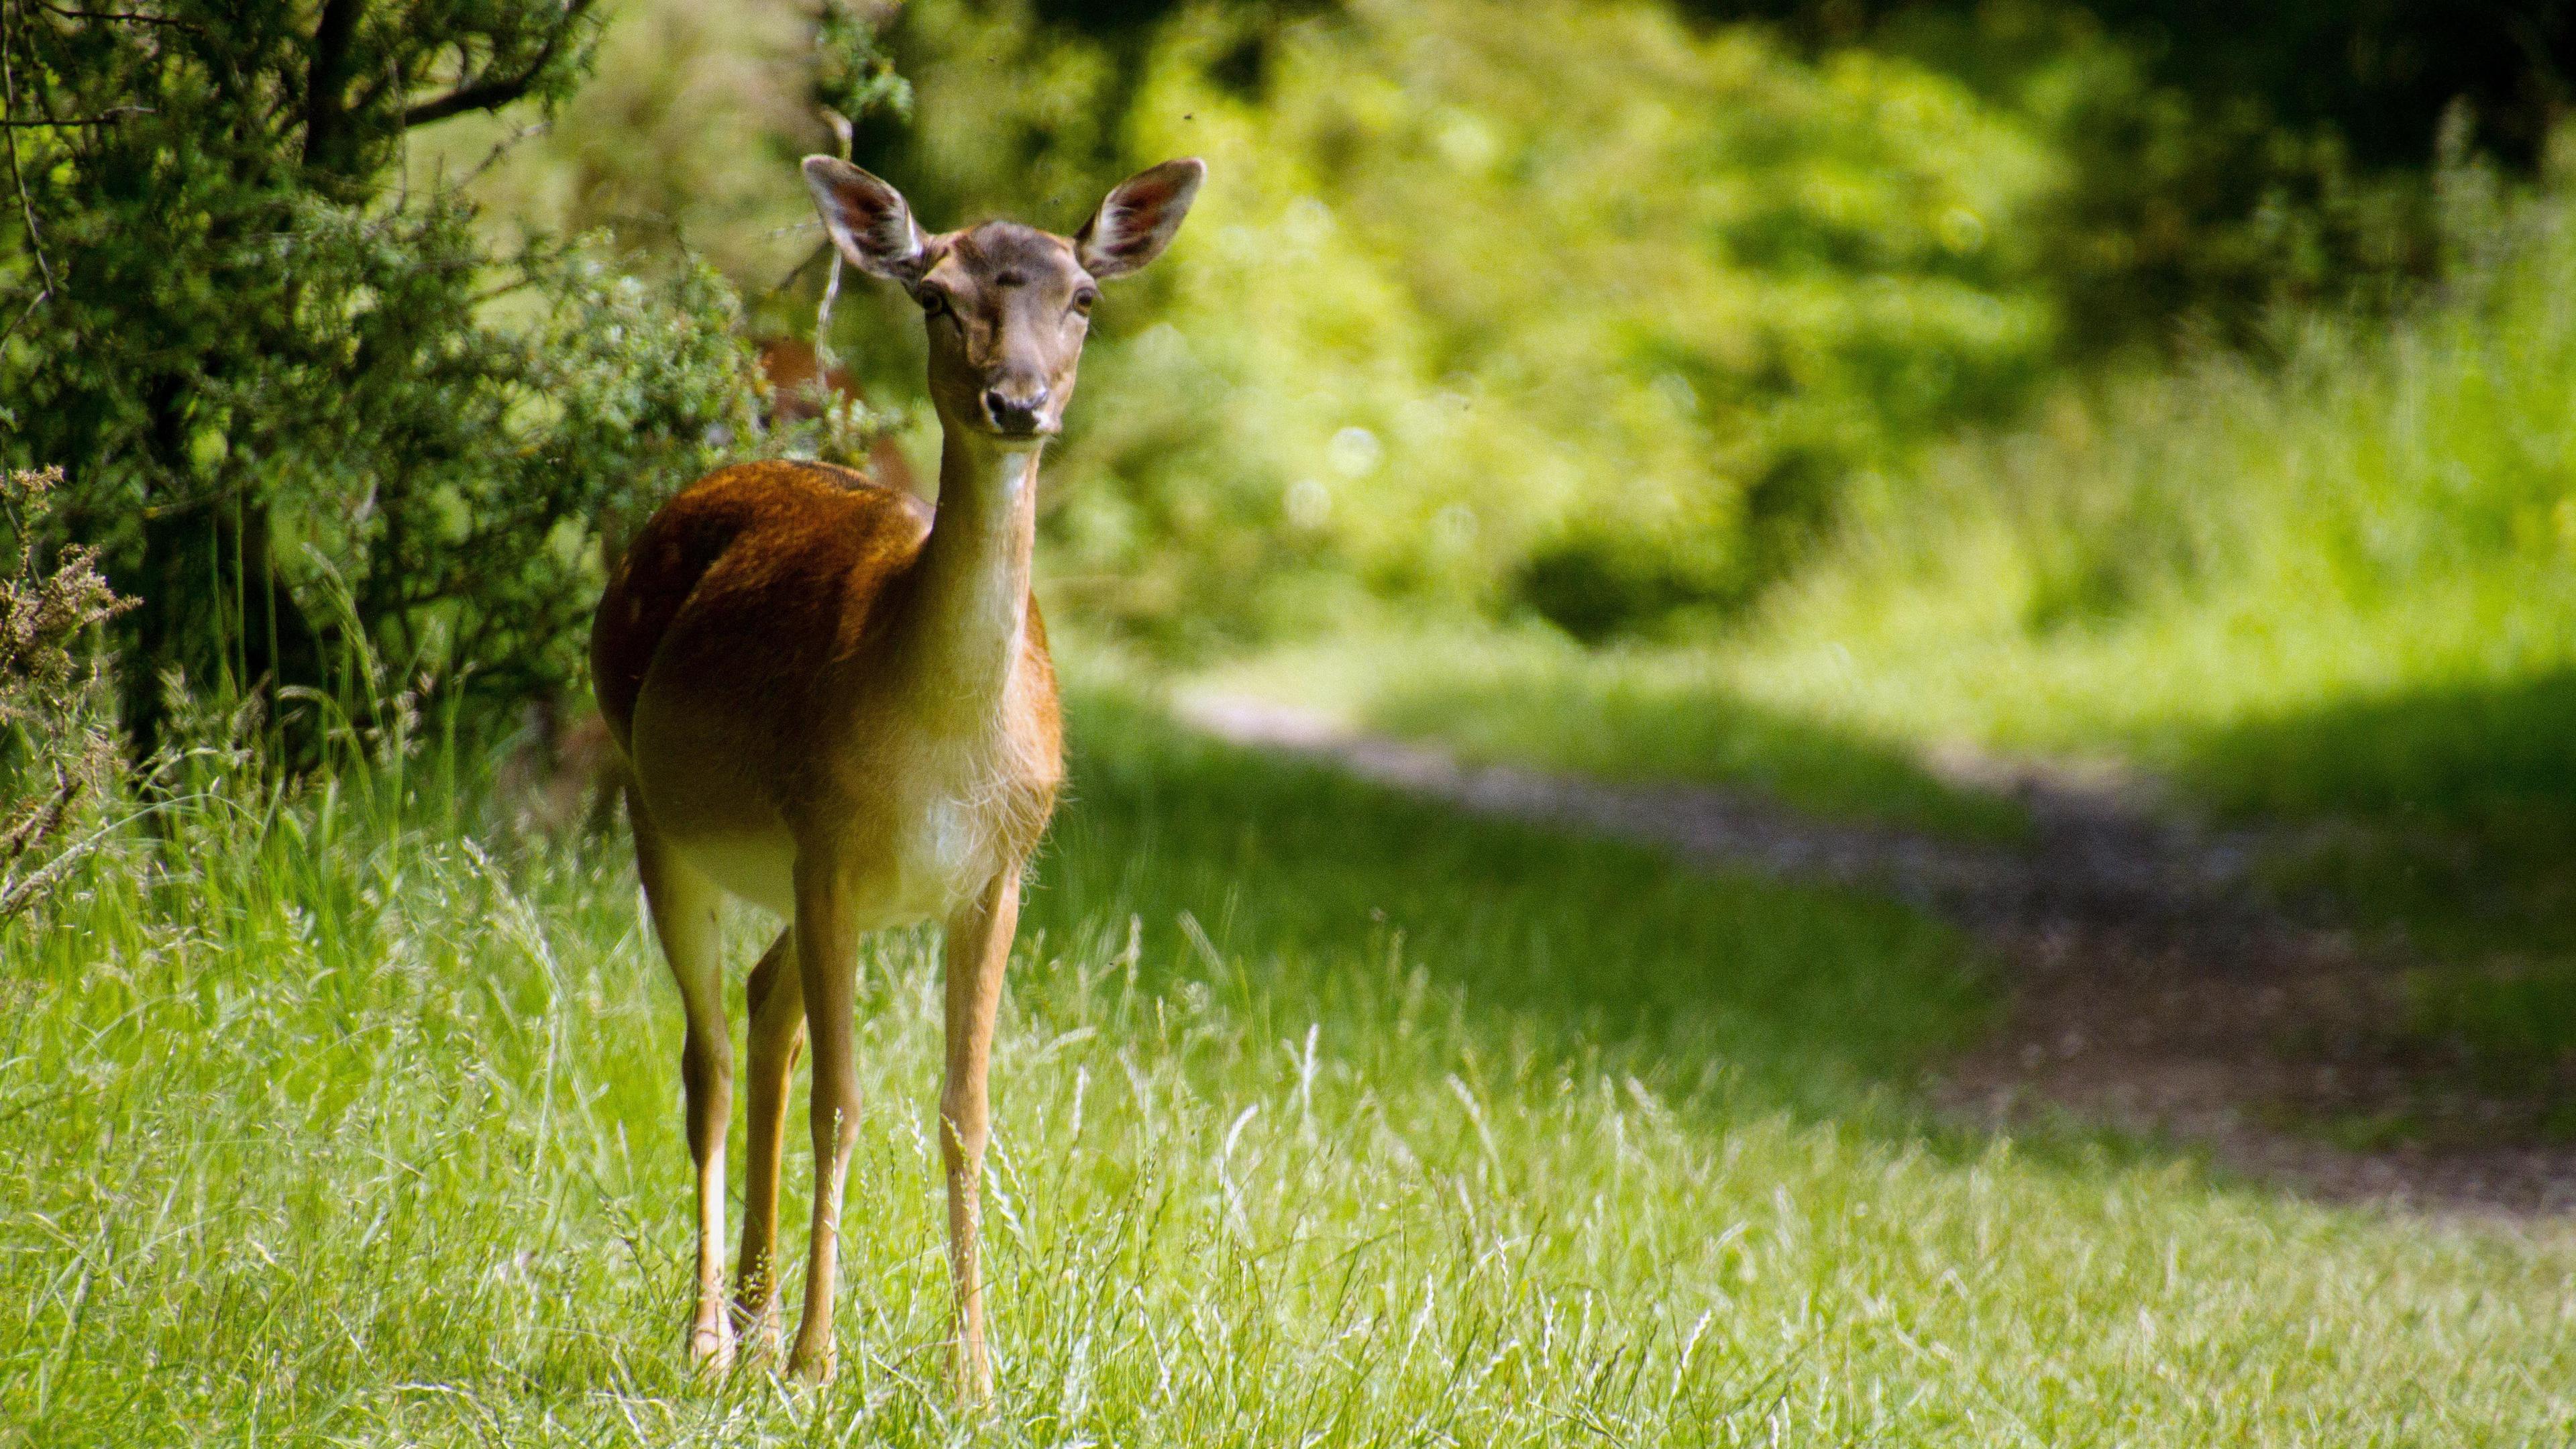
[590, 155, 1205, 1403]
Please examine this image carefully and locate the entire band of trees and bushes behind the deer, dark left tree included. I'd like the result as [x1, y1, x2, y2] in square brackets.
[25, 0, 2568, 711]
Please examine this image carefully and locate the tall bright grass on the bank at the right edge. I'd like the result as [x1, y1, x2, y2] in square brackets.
[1782, 137, 2576, 663]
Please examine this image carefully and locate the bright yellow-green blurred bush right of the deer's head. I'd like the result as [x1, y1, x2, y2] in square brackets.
[1035, 3, 2053, 634]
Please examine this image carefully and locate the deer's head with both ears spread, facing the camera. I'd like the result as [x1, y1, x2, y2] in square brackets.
[804, 155, 1208, 441]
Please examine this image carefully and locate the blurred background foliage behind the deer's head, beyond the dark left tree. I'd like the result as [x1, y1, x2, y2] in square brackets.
[412, 0, 2563, 644]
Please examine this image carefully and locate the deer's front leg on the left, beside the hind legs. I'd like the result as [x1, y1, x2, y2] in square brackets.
[788, 859, 858, 1382]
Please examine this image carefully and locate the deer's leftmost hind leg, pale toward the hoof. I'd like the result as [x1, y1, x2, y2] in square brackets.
[626, 792, 734, 1369]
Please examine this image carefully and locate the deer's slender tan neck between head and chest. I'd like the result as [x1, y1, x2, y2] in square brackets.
[907, 425, 1038, 730]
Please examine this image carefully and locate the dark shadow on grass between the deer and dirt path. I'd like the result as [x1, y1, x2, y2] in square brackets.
[1025, 694, 1999, 1134]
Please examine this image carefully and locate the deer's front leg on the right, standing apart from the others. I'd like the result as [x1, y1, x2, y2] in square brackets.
[941, 866, 1020, 1403]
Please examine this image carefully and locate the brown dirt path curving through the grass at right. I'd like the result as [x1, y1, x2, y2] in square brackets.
[1180, 694, 2576, 1214]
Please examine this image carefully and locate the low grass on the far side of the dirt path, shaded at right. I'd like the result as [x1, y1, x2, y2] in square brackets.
[1203, 590, 2576, 1093]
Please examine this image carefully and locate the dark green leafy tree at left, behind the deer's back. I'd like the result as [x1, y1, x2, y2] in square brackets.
[0, 0, 757, 740]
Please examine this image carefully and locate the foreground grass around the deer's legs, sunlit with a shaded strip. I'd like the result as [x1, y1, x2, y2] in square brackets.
[0, 694, 2576, 1446]
